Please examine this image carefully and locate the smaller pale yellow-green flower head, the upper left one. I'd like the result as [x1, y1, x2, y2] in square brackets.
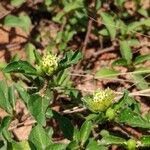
[37, 53, 58, 76]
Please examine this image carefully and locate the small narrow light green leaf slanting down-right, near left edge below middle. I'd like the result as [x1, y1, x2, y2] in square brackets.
[15, 82, 30, 104]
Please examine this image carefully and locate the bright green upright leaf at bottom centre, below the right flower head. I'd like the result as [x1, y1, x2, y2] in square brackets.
[80, 121, 92, 146]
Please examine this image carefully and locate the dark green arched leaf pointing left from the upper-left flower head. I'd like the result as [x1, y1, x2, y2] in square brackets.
[3, 60, 37, 75]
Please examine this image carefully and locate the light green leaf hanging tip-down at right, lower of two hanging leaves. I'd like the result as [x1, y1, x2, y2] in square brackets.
[120, 41, 132, 65]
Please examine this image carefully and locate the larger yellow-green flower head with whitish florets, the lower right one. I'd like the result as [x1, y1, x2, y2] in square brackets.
[83, 88, 115, 113]
